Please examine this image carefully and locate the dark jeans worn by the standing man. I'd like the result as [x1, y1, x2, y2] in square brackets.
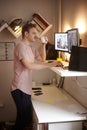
[11, 89, 32, 130]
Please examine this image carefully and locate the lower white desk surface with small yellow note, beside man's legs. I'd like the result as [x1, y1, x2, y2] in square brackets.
[32, 86, 87, 123]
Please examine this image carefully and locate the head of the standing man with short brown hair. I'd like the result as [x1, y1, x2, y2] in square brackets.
[22, 23, 38, 42]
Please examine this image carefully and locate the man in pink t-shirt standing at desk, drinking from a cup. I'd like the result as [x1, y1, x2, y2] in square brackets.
[11, 23, 61, 130]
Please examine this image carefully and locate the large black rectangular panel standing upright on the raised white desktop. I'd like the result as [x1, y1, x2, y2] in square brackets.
[68, 46, 87, 71]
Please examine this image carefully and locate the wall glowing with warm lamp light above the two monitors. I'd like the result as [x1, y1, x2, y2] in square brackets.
[61, 0, 87, 46]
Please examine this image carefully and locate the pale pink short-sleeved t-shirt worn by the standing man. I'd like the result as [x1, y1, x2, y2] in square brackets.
[11, 42, 39, 95]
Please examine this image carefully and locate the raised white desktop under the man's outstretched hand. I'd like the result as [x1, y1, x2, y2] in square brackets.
[51, 67, 87, 77]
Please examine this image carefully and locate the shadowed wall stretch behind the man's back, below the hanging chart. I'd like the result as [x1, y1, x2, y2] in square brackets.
[0, 61, 16, 121]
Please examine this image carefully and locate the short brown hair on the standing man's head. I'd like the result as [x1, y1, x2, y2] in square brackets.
[22, 23, 36, 38]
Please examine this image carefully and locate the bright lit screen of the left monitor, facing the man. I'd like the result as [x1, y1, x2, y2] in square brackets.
[55, 32, 68, 51]
